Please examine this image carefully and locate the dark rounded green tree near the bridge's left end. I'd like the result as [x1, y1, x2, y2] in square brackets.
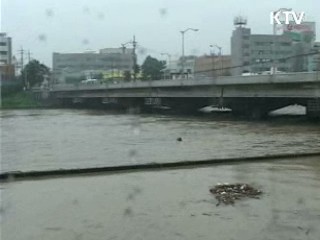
[21, 60, 50, 87]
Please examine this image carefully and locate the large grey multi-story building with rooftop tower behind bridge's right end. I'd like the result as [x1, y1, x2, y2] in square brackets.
[231, 26, 294, 75]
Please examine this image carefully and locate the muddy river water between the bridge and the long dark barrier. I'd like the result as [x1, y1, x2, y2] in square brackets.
[1, 109, 320, 171]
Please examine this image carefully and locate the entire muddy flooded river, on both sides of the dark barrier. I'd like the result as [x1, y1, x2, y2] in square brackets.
[0, 110, 320, 240]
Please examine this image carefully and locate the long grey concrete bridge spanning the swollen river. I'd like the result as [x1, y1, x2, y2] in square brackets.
[40, 72, 320, 118]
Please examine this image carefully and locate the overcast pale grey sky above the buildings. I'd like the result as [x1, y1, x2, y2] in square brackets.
[0, 0, 320, 67]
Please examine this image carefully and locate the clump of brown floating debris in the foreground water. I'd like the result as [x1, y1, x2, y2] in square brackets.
[210, 183, 262, 206]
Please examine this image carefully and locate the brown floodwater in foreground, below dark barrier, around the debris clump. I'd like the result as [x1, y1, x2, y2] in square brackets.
[0, 157, 320, 240]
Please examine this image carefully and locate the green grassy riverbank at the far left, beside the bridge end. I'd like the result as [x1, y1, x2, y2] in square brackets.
[0, 92, 43, 109]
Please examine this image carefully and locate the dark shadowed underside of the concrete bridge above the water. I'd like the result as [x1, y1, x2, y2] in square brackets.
[53, 97, 320, 119]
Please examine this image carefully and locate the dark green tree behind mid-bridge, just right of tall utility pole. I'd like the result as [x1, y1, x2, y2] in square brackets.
[141, 56, 166, 80]
